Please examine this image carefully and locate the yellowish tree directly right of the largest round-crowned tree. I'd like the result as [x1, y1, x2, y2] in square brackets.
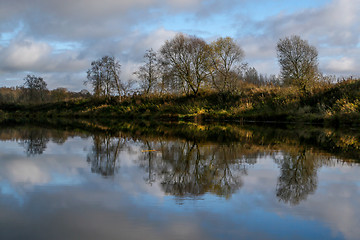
[210, 37, 245, 92]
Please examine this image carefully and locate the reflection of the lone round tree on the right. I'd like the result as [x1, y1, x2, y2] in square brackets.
[276, 149, 318, 205]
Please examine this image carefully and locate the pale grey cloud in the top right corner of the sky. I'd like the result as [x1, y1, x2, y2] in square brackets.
[256, 0, 360, 45]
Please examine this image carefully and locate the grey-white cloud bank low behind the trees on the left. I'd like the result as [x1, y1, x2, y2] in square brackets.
[0, 28, 176, 91]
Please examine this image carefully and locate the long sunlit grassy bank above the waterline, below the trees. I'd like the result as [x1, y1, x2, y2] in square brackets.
[0, 80, 360, 125]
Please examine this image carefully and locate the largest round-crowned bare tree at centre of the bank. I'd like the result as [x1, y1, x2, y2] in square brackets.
[160, 34, 210, 95]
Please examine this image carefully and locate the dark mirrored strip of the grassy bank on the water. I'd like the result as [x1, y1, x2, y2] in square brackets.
[0, 119, 360, 162]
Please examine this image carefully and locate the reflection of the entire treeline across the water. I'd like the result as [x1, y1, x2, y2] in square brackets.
[0, 125, 358, 205]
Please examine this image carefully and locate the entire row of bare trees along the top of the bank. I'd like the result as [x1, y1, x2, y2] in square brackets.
[0, 33, 358, 104]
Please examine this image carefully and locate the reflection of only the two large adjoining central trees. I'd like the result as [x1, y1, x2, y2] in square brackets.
[162, 142, 246, 197]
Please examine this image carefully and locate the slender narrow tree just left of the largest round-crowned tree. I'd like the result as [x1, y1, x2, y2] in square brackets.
[134, 48, 159, 94]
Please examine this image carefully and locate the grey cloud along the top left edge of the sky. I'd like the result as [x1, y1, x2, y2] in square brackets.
[2, 0, 202, 42]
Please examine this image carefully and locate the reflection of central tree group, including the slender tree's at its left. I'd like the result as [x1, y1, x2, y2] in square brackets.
[140, 140, 253, 197]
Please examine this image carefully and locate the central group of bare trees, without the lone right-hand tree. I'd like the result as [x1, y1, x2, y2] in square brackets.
[85, 34, 280, 97]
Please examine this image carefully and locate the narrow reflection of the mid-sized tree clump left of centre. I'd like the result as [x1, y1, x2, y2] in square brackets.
[87, 135, 126, 176]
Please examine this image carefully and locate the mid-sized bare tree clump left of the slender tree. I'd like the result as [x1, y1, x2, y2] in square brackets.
[84, 56, 122, 97]
